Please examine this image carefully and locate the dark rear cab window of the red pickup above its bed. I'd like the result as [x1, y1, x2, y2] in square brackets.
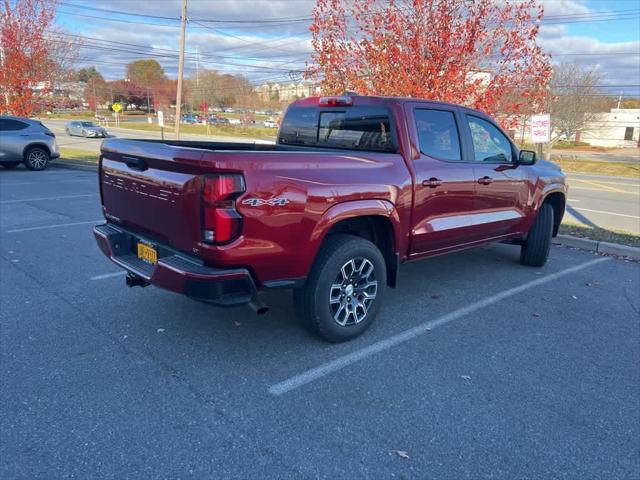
[278, 106, 397, 152]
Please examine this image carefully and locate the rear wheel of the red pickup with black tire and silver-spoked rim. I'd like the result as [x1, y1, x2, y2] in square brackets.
[294, 234, 387, 342]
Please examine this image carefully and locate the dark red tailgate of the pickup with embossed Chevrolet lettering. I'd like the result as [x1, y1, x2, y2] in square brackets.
[100, 139, 204, 252]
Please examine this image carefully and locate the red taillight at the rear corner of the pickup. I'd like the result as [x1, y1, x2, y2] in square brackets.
[202, 174, 244, 244]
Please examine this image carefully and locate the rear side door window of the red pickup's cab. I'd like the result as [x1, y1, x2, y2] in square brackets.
[414, 108, 462, 162]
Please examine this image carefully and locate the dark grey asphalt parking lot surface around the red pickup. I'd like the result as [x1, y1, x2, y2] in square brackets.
[0, 168, 640, 479]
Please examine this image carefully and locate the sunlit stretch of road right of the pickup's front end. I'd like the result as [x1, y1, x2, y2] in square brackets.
[565, 173, 640, 235]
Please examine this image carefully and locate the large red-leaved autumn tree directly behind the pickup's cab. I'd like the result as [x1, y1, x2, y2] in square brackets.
[306, 0, 551, 124]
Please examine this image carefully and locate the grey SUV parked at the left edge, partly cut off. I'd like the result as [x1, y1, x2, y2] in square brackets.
[0, 115, 60, 170]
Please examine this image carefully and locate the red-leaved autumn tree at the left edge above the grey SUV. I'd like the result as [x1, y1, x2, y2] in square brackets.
[0, 0, 57, 117]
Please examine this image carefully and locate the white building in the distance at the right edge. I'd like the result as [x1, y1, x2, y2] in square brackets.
[575, 108, 640, 147]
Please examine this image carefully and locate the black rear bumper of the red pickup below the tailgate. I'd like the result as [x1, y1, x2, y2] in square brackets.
[93, 223, 257, 307]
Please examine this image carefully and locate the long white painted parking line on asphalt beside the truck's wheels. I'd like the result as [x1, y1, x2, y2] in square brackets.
[269, 257, 612, 396]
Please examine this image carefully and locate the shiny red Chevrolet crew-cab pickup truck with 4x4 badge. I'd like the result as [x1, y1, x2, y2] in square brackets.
[94, 96, 567, 341]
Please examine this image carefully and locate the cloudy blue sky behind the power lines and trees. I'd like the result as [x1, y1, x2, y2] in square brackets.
[57, 0, 640, 94]
